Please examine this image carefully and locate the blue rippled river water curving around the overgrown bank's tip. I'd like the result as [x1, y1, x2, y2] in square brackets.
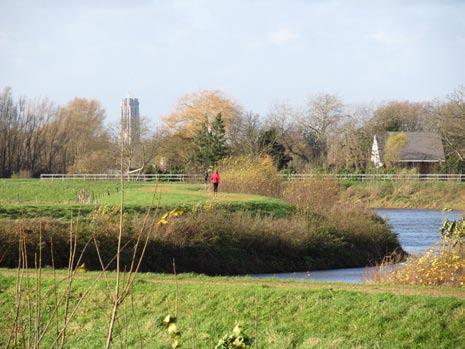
[253, 208, 462, 283]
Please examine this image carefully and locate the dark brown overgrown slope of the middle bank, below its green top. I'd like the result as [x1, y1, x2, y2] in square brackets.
[0, 207, 402, 275]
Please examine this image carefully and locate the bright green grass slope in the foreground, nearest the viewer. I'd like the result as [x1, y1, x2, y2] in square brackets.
[0, 270, 465, 349]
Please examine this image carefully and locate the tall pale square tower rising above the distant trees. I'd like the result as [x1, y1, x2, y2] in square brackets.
[120, 98, 140, 145]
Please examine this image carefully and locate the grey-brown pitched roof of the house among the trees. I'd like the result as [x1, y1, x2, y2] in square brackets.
[375, 132, 445, 162]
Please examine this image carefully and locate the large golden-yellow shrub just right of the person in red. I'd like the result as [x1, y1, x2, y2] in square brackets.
[220, 156, 282, 197]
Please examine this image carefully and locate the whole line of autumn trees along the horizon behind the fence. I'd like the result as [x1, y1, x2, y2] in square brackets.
[0, 87, 465, 177]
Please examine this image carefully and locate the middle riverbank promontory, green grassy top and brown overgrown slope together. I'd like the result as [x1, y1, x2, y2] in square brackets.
[0, 180, 403, 275]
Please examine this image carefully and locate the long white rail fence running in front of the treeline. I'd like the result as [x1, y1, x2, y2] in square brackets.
[40, 173, 465, 182]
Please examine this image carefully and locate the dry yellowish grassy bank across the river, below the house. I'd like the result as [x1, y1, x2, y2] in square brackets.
[340, 181, 465, 210]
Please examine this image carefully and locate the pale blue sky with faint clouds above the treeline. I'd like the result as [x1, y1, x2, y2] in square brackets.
[0, 0, 465, 121]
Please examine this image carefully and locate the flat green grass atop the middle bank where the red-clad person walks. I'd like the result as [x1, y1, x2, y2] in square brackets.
[0, 179, 293, 217]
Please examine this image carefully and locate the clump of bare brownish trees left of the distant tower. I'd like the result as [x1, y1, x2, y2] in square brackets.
[0, 88, 115, 177]
